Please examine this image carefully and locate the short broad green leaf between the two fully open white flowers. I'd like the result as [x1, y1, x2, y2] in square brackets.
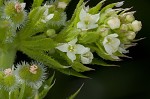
[79, 32, 99, 44]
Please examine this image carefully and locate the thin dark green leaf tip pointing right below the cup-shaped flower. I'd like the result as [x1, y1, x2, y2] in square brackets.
[91, 58, 117, 66]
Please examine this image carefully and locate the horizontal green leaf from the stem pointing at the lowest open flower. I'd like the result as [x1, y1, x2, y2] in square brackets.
[21, 38, 57, 51]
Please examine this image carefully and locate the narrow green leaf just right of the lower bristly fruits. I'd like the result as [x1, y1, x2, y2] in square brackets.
[39, 73, 55, 99]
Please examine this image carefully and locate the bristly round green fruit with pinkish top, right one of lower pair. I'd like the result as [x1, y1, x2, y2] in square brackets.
[15, 62, 46, 89]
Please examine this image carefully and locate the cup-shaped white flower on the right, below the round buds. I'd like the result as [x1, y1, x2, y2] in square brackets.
[103, 34, 120, 59]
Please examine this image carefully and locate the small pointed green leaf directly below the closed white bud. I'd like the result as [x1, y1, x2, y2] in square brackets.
[72, 61, 94, 72]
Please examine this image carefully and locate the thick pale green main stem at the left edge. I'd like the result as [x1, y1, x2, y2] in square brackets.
[0, 44, 16, 69]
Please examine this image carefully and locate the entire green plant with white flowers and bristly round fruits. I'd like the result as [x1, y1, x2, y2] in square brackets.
[0, 0, 142, 99]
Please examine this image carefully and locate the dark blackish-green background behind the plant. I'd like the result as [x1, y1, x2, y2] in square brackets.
[19, 0, 150, 99]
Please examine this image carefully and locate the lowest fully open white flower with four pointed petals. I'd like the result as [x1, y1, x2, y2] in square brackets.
[56, 38, 89, 62]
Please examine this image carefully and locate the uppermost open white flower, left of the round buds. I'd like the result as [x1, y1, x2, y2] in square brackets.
[77, 7, 100, 30]
